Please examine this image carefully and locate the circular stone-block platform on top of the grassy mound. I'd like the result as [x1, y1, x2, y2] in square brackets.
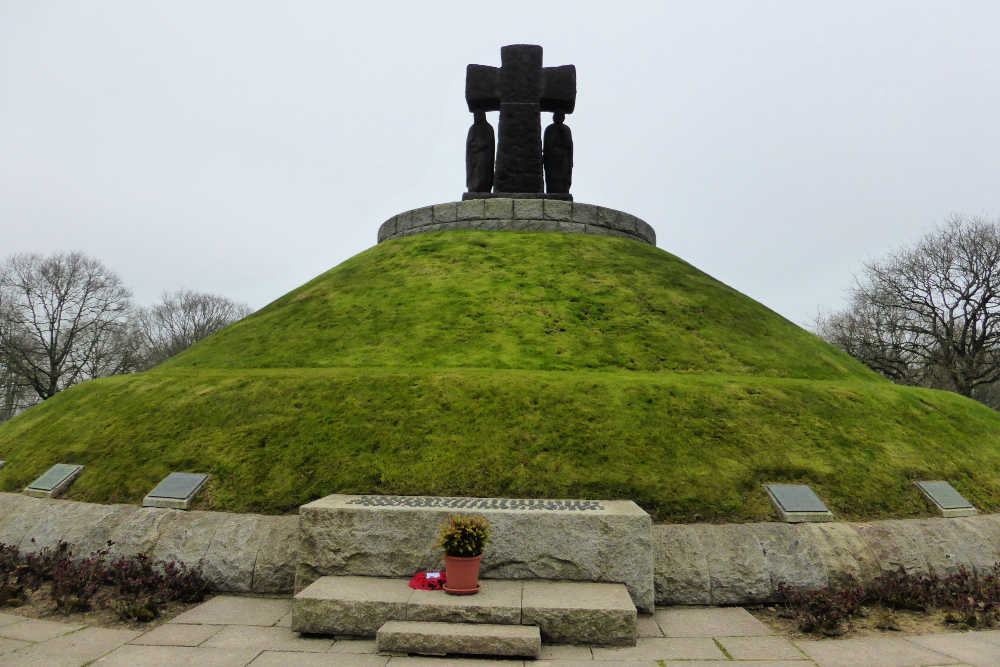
[378, 197, 656, 246]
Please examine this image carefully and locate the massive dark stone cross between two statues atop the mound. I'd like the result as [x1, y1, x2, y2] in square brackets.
[465, 44, 576, 198]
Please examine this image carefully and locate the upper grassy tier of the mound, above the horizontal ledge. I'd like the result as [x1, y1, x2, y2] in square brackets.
[163, 232, 875, 379]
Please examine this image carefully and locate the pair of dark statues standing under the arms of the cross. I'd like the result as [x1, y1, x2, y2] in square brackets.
[465, 111, 573, 194]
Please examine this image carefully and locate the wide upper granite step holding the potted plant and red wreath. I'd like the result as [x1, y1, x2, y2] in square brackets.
[292, 576, 636, 646]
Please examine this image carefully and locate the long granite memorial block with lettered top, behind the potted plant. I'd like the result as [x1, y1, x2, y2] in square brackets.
[295, 495, 653, 612]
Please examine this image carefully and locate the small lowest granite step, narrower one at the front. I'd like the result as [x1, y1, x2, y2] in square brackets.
[375, 621, 542, 658]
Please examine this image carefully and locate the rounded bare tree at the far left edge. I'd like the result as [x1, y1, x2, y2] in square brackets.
[0, 252, 131, 400]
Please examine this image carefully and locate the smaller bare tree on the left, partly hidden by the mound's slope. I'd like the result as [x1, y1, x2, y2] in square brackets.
[137, 290, 253, 368]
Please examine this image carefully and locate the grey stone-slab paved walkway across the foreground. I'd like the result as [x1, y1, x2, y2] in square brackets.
[0, 595, 1000, 667]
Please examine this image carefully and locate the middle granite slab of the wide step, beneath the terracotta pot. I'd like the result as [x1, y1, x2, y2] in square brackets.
[400, 579, 524, 625]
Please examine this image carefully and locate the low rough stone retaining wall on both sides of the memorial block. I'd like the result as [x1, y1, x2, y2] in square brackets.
[7, 493, 1000, 605]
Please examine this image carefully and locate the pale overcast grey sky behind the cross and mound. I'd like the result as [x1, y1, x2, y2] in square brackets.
[0, 0, 1000, 324]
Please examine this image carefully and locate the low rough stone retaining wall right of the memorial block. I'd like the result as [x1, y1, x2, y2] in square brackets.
[653, 514, 1000, 605]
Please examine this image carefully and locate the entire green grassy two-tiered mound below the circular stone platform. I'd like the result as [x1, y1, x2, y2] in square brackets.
[0, 232, 1000, 521]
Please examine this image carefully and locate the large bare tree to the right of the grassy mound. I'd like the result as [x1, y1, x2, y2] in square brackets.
[817, 216, 1000, 397]
